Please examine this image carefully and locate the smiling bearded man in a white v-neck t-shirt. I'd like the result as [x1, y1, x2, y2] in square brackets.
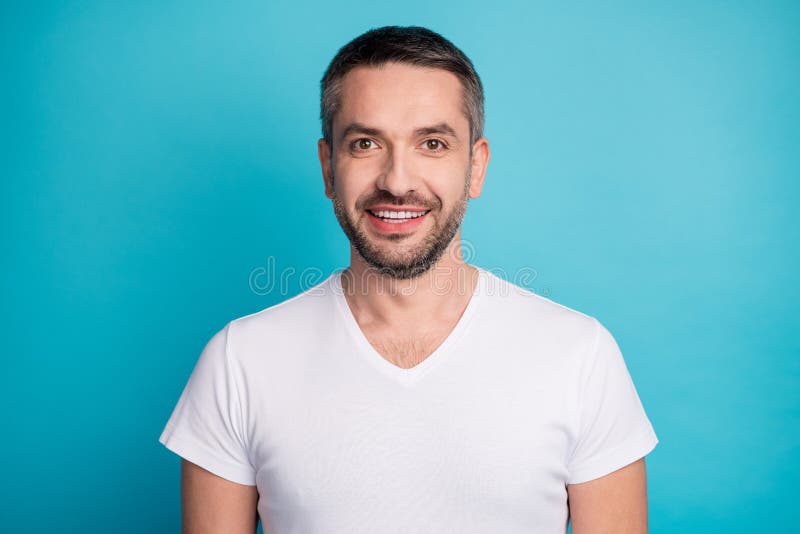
[160, 27, 658, 534]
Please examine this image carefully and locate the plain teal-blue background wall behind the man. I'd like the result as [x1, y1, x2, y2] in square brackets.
[0, 1, 800, 533]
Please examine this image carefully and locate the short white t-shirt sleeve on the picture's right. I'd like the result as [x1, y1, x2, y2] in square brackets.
[567, 320, 658, 484]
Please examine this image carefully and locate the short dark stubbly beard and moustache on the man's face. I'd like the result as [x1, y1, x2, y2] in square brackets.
[332, 169, 472, 280]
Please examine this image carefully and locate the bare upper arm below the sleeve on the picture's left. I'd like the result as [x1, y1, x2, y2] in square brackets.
[181, 460, 258, 534]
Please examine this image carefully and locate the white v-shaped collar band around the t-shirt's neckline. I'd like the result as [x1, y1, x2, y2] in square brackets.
[329, 266, 488, 386]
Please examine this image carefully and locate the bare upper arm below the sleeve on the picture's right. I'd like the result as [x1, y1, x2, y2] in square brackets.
[567, 458, 647, 534]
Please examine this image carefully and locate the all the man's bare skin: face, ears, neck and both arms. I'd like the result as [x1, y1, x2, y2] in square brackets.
[182, 64, 647, 534]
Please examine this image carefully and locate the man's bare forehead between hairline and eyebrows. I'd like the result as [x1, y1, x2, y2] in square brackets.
[334, 63, 469, 137]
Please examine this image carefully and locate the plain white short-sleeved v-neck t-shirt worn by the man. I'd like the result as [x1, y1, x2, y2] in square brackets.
[159, 268, 658, 534]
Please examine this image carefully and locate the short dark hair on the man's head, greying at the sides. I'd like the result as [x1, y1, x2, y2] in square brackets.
[320, 26, 484, 145]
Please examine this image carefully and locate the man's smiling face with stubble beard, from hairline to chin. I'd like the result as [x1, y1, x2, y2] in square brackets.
[320, 64, 482, 278]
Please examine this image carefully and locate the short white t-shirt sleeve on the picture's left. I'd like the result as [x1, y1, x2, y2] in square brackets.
[159, 323, 255, 486]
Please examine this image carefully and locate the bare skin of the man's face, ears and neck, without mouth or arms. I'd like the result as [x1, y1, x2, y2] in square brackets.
[318, 64, 489, 368]
